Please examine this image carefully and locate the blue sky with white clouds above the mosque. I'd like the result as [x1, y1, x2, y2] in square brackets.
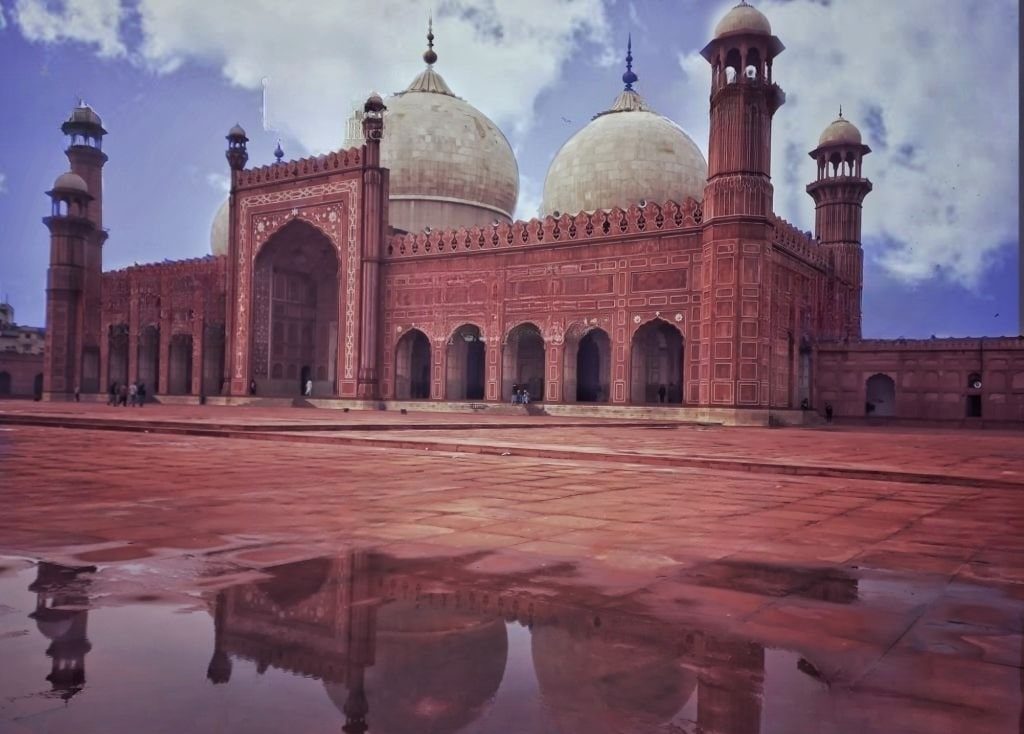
[0, 0, 1019, 337]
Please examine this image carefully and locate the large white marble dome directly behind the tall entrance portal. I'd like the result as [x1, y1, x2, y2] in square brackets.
[346, 28, 519, 231]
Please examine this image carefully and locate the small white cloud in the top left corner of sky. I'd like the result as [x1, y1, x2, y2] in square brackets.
[12, 0, 125, 57]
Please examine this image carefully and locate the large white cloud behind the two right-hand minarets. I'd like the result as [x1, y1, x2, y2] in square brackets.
[677, 0, 1019, 288]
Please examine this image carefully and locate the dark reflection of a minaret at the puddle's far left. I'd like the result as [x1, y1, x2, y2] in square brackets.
[29, 563, 96, 701]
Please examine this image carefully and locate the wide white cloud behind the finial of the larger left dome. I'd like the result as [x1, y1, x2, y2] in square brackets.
[129, 0, 608, 152]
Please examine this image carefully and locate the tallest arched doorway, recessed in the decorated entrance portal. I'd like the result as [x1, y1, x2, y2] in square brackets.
[252, 219, 339, 395]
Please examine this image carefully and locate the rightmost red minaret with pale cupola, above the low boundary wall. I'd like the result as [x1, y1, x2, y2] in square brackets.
[807, 107, 871, 339]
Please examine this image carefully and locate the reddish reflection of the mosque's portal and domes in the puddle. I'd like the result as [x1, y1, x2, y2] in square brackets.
[207, 552, 819, 734]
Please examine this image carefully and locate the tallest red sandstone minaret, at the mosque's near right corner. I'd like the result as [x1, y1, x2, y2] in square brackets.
[691, 1, 785, 407]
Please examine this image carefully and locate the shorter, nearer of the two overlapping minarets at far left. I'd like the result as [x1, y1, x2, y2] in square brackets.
[43, 171, 98, 400]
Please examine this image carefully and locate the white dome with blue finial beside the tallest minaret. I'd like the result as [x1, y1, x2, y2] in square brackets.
[541, 41, 708, 214]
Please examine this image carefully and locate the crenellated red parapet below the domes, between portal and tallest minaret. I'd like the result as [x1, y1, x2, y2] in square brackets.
[385, 199, 703, 259]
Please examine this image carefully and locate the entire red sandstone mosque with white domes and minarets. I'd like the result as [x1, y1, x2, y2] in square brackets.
[37, 2, 1024, 424]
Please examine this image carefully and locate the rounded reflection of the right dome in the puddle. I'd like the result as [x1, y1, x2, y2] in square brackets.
[531, 625, 696, 734]
